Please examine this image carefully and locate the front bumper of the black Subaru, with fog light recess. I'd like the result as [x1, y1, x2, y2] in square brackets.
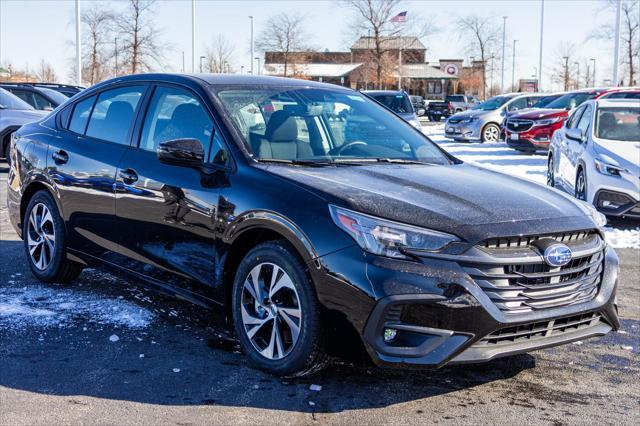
[320, 236, 619, 368]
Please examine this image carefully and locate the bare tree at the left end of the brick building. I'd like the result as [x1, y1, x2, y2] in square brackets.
[251, 12, 309, 77]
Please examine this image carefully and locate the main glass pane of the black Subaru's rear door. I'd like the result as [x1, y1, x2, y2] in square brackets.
[85, 86, 145, 145]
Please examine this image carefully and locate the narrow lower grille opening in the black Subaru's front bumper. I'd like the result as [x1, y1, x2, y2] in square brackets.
[473, 312, 603, 347]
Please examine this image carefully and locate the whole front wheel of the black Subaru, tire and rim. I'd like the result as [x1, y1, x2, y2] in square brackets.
[232, 240, 328, 377]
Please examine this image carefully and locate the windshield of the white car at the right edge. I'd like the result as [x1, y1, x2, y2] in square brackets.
[596, 107, 640, 142]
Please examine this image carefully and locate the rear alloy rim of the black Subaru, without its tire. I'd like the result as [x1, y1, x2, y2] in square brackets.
[27, 203, 56, 271]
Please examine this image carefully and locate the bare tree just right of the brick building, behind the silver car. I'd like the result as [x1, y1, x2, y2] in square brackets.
[456, 14, 498, 99]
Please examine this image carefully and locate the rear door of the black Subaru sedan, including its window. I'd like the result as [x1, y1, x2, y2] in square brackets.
[47, 85, 146, 259]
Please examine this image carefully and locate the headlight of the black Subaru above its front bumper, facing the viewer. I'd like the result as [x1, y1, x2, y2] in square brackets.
[329, 205, 458, 259]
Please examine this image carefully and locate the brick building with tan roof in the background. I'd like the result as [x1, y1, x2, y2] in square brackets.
[263, 37, 483, 99]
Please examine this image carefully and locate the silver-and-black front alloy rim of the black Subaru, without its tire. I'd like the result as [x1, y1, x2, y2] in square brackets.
[240, 263, 302, 360]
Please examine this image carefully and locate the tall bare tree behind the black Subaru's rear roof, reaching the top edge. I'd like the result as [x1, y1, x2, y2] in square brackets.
[117, 0, 163, 74]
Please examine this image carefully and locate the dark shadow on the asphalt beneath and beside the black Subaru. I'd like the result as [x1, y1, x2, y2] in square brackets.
[0, 236, 535, 413]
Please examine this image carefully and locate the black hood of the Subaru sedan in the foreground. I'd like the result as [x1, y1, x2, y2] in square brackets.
[267, 164, 594, 239]
